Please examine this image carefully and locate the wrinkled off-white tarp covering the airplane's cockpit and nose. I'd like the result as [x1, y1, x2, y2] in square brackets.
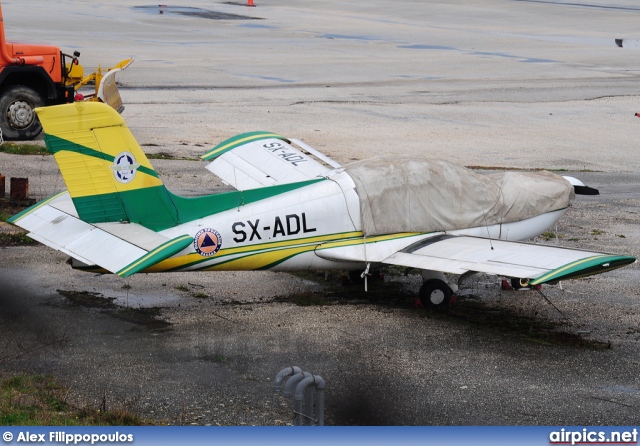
[344, 156, 574, 235]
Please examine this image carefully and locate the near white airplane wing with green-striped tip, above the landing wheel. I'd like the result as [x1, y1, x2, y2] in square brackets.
[316, 234, 636, 285]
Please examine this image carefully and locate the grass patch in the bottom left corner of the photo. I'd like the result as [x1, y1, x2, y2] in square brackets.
[0, 374, 148, 426]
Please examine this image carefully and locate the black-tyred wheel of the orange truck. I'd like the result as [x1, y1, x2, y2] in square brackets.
[0, 85, 44, 140]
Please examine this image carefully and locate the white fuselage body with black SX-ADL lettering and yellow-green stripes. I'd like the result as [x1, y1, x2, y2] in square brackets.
[161, 170, 566, 270]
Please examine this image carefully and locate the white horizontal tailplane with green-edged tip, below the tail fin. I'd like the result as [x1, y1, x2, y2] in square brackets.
[9, 191, 193, 277]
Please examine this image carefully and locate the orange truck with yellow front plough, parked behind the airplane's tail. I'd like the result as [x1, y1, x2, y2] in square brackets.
[0, 3, 133, 141]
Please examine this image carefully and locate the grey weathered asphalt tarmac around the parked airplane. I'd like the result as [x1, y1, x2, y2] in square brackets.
[0, 0, 640, 425]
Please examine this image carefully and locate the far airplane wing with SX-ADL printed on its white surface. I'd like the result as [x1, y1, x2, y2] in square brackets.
[201, 132, 340, 190]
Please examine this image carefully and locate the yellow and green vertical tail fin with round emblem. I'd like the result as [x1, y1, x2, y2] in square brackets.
[36, 102, 179, 231]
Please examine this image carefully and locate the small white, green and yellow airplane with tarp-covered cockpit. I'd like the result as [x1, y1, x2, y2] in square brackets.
[9, 102, 636, 307]
